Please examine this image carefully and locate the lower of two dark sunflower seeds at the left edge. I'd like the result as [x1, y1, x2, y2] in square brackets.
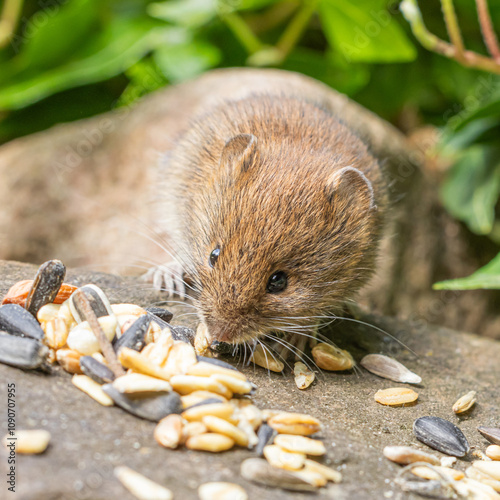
[0, 334, 49, 370]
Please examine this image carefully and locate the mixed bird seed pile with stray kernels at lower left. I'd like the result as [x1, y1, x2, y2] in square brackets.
[0, 260, 341, 499]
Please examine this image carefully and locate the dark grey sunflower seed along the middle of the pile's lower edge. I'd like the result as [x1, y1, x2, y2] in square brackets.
[102, 384, 183, 422]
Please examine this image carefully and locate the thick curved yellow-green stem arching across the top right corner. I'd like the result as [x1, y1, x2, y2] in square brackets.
[400, 0, 500, 75]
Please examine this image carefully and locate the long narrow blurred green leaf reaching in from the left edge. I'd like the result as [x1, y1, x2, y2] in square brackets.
[0, 20, 172, 110]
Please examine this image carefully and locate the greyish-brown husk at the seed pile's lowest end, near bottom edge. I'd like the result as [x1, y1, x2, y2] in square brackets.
[240, 458, 316, 491]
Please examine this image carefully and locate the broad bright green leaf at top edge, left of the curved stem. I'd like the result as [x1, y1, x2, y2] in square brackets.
[319, 0, 417, 62]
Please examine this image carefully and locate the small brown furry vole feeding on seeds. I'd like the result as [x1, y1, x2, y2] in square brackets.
[148, 93, 387, 343]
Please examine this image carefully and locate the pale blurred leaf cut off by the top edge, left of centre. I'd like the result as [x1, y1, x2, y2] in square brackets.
[147, 0, 217, 28]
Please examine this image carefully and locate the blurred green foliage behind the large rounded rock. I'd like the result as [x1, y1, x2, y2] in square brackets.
[0, 0, 500, 286]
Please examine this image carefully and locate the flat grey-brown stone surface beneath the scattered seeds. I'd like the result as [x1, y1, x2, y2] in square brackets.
[0, 262, 500, 500]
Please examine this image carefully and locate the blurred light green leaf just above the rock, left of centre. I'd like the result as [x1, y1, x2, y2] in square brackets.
[153, 40, 221, 83]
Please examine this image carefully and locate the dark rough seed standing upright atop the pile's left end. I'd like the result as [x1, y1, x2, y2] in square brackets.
[25, 260, 66, 318]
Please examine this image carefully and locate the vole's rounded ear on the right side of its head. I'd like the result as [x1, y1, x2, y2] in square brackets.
[326, 167, 377, 210]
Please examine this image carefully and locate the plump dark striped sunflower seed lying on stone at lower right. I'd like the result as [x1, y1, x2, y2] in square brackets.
[413, 417, 470, 457]
